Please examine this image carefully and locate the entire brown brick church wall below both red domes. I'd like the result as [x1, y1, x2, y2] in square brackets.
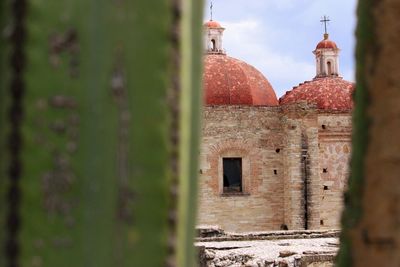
[198, 104, 351, 232]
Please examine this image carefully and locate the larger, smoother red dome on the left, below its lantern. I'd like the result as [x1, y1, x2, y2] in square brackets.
[203, 54, 279, 106]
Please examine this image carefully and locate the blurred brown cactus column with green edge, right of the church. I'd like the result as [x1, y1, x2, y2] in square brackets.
[338, 0, 400, 267]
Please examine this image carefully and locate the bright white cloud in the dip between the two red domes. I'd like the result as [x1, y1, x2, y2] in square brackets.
[222, 19, 315, 97]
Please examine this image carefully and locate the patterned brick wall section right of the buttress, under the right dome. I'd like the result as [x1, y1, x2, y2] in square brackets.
[319, 114, 351, 229]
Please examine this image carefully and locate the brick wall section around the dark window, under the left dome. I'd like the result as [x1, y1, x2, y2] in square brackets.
[198, 106, 284, 232]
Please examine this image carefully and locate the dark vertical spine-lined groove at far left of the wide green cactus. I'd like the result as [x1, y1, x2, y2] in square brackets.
[2, 0, 27, 266]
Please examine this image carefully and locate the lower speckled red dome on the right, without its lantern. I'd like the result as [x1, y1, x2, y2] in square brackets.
[279, 77, 355, 111]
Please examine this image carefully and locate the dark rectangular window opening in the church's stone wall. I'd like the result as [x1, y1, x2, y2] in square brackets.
[223, 158, 242, 193]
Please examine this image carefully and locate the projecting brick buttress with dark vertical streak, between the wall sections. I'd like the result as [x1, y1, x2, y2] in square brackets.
[282, 103, 320, 230]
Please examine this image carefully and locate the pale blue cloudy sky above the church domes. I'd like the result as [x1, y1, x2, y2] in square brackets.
[204, 0, 357, 97]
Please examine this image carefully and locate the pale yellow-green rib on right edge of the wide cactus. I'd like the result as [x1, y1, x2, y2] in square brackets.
[177, 0, 203, 267]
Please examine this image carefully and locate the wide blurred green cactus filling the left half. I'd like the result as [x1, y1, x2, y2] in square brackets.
[0, 0, 202, 267]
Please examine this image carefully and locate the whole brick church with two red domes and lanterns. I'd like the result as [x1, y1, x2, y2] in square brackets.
[198, 21, 355, 232]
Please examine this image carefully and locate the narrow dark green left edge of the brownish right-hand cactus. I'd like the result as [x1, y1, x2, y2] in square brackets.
[337, 0, 374, 267]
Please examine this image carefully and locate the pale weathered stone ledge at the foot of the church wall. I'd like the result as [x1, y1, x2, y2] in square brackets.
[195, 238, 339, 267]
